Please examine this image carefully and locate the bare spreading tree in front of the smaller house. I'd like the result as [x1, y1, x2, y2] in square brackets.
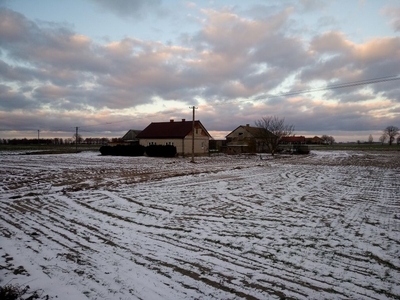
[255, 116, 294, 156]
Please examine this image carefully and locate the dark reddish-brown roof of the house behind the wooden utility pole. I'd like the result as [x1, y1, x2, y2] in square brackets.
[136, 119, 211, 139]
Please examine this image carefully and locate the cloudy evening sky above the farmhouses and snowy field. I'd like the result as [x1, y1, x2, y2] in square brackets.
[0, 0, 400, 141]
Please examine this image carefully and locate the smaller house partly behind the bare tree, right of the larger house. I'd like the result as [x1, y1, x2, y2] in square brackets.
[226, 124, 272, 154]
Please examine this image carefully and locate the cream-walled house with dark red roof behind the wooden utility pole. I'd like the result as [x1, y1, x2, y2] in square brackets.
[136, 119, 212, 155]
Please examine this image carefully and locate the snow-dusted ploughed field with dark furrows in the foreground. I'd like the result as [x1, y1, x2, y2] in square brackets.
[0, 151, 400, 300]
